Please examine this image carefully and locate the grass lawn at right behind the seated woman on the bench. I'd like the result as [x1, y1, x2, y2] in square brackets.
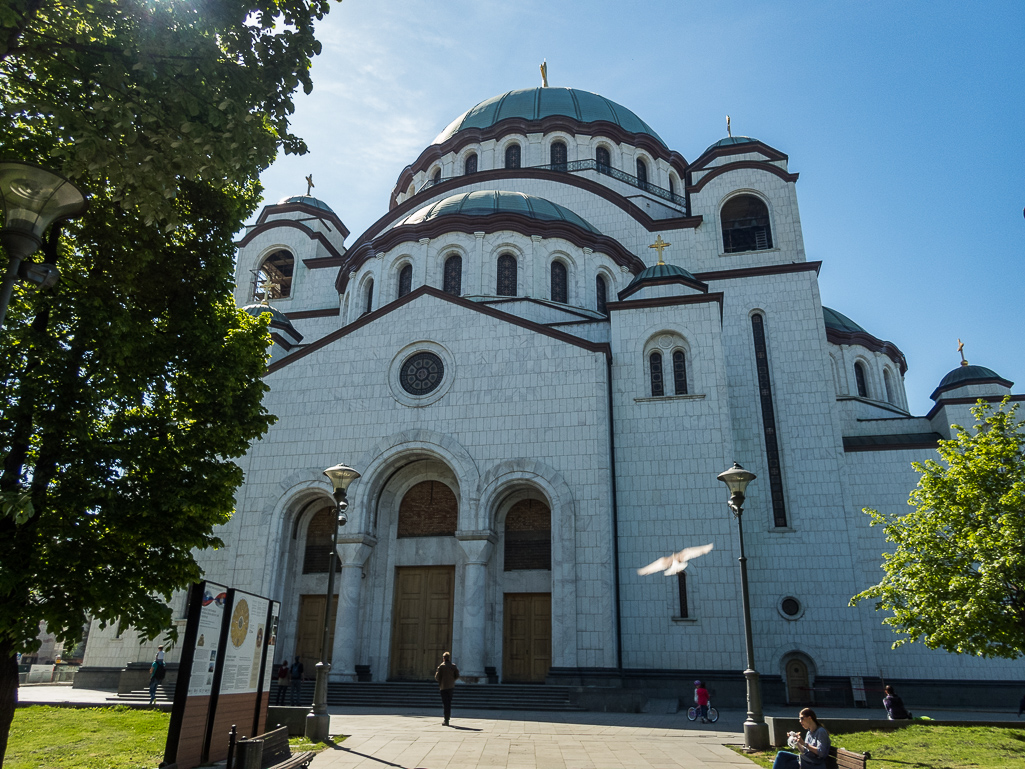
[735, 724, 1025, 769]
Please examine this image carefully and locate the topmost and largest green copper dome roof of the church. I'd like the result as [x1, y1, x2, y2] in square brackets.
[433, 88, 665, 147]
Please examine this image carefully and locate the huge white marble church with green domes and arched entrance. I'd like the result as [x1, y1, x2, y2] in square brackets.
[77, 87, 1022, 706]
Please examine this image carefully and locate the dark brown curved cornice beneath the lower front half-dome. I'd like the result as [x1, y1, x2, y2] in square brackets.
[335, 211, 645, 293]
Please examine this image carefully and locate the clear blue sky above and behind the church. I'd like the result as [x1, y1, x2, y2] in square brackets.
[256, 0, 1025, 413]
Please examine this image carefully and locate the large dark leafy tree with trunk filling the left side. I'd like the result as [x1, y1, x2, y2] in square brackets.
[0, 0, 329, 765]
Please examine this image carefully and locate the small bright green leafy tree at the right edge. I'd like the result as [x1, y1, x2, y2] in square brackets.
[851, 399, 1025, 659]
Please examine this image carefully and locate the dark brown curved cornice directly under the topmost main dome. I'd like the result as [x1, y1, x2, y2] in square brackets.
[391, 115, 687, 207]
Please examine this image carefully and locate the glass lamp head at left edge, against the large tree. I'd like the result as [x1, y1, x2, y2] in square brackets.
[0, 160, 89, 258]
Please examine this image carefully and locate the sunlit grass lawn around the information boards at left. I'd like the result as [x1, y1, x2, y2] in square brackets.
[3, 705, 343, 769]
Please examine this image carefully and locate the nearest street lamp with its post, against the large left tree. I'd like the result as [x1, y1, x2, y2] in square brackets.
[0, 161, 88, 328]
